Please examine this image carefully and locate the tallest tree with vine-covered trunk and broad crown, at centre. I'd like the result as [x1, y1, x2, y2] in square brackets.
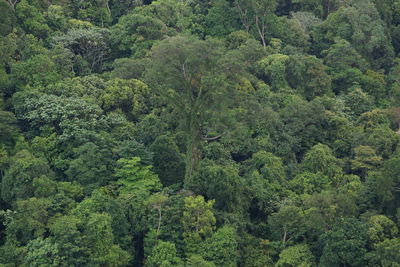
[146, 36, 242, 186]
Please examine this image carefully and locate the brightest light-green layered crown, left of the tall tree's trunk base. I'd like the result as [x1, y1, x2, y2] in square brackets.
[114, 157, 161, 194]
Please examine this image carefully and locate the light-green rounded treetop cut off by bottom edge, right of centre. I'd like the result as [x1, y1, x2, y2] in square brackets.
[275, 244, 316, 267]
